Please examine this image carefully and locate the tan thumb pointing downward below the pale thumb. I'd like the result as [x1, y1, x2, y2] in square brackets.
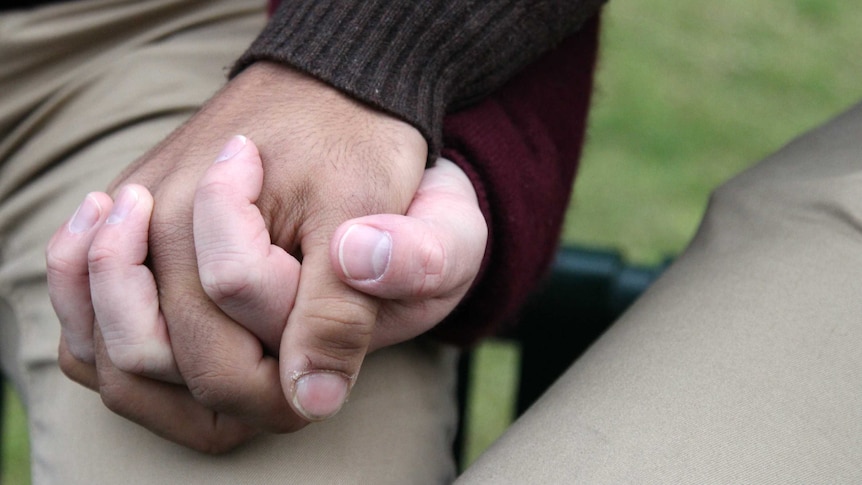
[280, 246, 379, 421]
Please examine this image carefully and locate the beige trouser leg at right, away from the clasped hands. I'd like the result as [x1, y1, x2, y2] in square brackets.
[459, 105, 862, 484]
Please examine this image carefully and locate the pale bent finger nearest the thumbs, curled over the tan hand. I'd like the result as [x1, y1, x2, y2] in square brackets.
[194, 136, 300, 355]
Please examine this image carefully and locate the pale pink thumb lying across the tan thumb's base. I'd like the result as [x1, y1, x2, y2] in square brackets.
[330, 159, 488, 300]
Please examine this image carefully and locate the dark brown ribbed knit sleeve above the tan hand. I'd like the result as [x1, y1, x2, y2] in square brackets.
[232, 0, 604, 160]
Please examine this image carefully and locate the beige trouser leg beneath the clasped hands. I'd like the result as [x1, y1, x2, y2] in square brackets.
[0, 0, 456, 485]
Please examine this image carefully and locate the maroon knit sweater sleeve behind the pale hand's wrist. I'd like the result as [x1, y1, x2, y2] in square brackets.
[433, 17, 599, 345]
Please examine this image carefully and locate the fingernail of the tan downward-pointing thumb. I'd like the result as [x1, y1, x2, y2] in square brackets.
[293, 372, 350, 421]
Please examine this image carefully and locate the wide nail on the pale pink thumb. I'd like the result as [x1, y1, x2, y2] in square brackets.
[338, 224, 392, 280]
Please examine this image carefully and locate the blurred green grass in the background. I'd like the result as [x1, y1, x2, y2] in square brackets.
[0, 0, 862, 478]
